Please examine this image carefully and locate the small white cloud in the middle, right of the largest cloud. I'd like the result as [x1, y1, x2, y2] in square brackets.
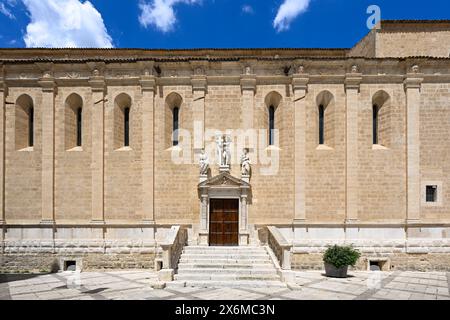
[139, 0, 201, 32]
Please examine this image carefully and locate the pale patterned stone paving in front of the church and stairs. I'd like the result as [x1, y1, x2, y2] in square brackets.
[0, 270, 450, 300]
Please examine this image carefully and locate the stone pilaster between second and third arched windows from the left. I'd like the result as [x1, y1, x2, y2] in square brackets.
[89, 70, 106, 224]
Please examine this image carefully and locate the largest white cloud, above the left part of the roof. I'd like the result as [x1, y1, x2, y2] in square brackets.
[22, 0, 113, 48]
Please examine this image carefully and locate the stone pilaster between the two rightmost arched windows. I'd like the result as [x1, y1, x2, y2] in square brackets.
[345, 67, 362, 222]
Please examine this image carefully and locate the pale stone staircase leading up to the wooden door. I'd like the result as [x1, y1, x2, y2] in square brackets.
[170, 246, 286, 288]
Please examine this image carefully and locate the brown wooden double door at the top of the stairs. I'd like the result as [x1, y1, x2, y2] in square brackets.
[209, 199, 239, 246]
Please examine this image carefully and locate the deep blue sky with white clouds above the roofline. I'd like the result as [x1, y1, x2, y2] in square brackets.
[0, 0, 450, 48]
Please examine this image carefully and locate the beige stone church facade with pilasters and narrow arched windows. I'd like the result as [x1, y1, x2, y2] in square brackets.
[0, 21, 450, 270]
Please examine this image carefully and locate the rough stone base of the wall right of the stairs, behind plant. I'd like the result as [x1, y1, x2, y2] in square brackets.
[291, 253, 450, 272]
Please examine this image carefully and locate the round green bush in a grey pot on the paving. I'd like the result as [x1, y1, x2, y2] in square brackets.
[323, 245, 361, 278]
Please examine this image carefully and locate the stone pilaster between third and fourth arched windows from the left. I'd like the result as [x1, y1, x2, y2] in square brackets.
[140, 74, 156, 224]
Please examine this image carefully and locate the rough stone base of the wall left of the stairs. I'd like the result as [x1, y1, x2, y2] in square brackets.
[0, 253, 156, 273]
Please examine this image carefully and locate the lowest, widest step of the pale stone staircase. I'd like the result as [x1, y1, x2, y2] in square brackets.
[166, 280, 287, 288]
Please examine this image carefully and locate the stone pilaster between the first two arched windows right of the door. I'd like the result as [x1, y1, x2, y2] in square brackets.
[292, 73, 309, 222]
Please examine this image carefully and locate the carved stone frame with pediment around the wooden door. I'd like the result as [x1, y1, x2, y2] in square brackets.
[198, 172, 251, 246]
